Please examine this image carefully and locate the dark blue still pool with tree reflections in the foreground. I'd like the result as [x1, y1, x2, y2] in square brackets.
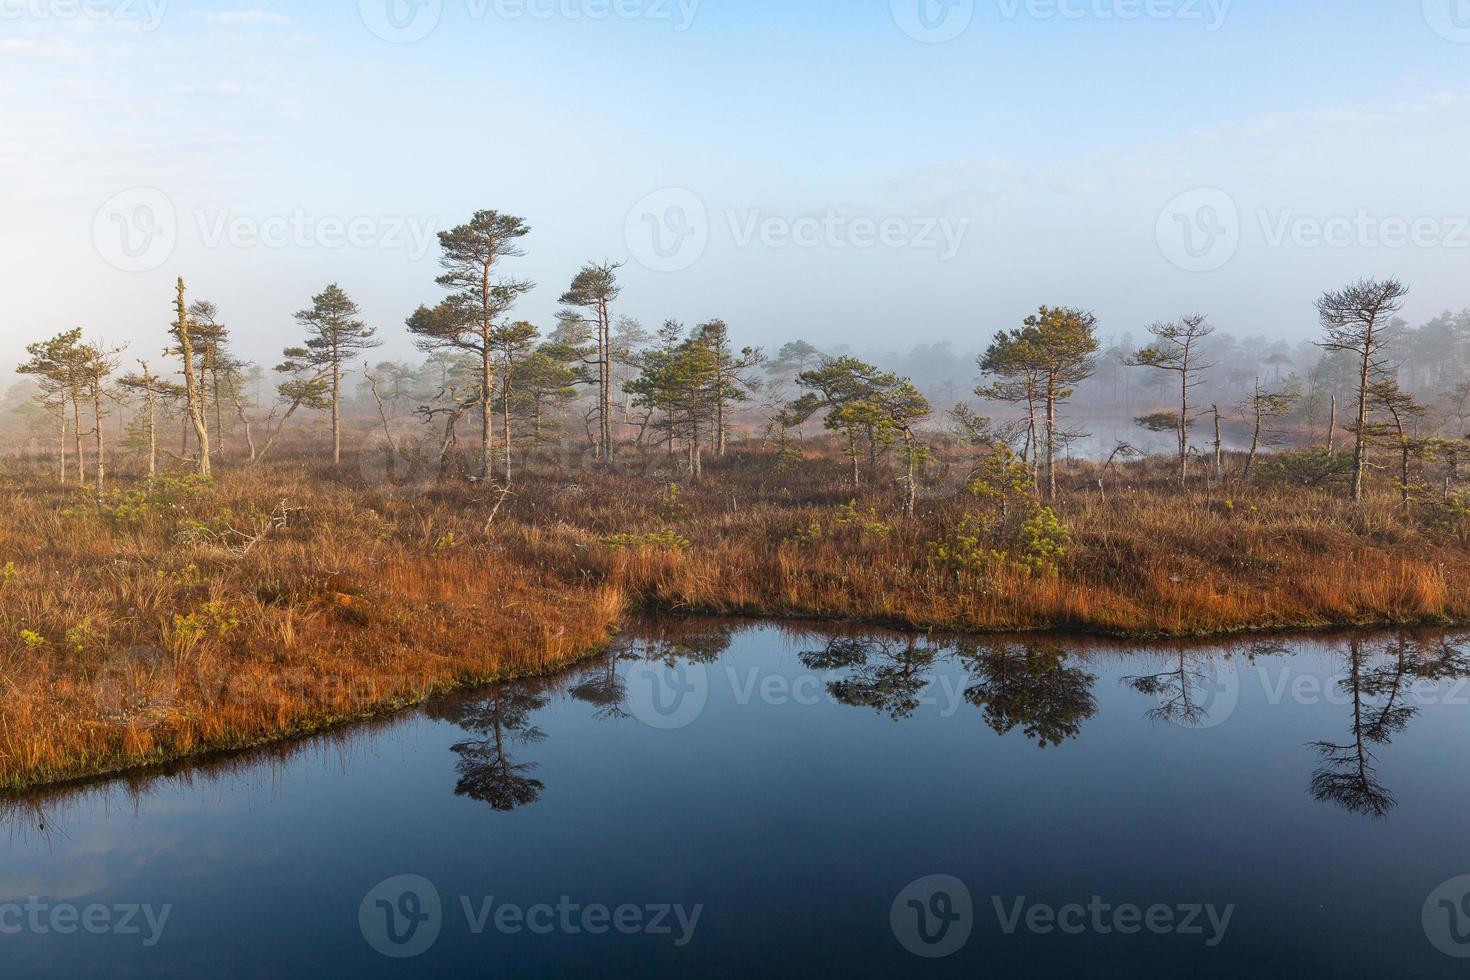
[0, 621, 1470, 977]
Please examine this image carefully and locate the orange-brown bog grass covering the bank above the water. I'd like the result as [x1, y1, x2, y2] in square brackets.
[0, 440, 1470, 789]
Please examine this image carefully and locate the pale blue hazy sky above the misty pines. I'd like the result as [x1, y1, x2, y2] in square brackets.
[0, 0, 1470, 379]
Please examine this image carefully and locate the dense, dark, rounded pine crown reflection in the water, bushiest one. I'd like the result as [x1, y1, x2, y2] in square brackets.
[960, 642, 1098, 749]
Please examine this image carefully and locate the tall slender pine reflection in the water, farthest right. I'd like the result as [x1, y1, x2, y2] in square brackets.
[1311, 636, 1470, 818]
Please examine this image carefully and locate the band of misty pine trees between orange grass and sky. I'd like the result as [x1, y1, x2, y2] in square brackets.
[6, 212, 1470, 508]
